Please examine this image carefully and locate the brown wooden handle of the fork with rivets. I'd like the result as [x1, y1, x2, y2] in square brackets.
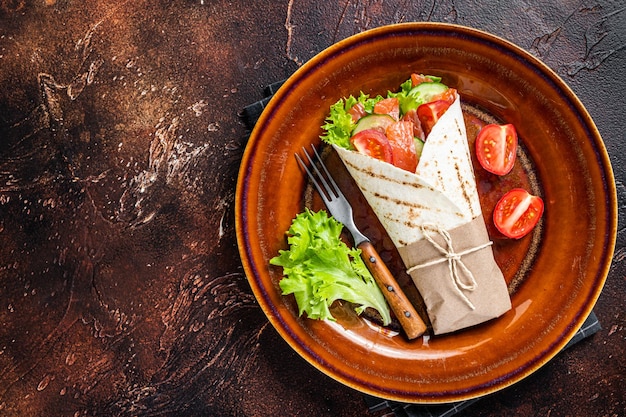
[358, 241, 426, 339]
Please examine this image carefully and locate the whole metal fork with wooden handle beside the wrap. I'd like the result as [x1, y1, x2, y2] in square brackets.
[295, 145, 426, 339]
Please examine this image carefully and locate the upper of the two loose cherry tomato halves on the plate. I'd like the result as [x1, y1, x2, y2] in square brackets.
[476, 124, 517, 175]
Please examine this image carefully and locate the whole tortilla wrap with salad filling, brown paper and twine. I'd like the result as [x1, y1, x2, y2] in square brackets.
[322, 74, 511, 334]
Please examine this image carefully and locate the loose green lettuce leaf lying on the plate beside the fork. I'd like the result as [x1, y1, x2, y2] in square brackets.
[270, 209, 391, 325]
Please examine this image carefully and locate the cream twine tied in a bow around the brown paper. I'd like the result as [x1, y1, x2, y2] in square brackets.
[407, 223, 493, 310]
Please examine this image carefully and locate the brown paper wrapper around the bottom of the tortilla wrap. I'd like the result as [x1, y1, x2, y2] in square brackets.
[398, 216, 511, 335]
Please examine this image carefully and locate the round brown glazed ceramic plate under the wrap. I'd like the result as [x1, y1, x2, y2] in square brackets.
[236, 23, 617, 403]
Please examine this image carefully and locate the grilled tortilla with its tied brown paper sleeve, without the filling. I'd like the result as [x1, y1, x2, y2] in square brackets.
[334, 95, 511, 334]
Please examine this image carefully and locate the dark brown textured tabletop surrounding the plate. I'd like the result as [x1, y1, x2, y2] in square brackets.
[0, 0, 626, 417]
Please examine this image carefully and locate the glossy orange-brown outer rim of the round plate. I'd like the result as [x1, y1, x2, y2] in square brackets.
[235, 22, 618, 404]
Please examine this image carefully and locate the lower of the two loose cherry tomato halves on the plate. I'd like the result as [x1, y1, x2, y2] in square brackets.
[493, 188, 543, 239]
